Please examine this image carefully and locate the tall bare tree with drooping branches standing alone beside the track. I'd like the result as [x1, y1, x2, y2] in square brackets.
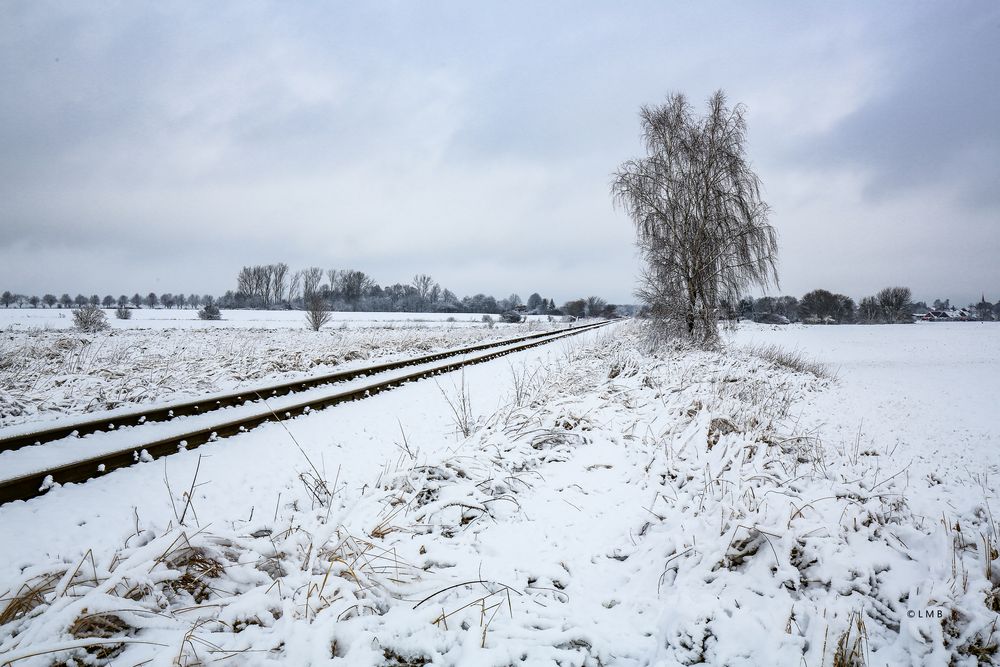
[611, 91, 778, 343]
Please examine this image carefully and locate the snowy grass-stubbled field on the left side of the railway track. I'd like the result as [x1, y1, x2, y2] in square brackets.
[0, 310, 564, 428]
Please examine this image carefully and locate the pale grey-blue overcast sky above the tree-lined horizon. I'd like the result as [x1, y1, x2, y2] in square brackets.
[0, 0, 1000, 304]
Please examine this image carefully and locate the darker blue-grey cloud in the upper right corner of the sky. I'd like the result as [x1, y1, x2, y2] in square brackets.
[804, 2, 1000, 207]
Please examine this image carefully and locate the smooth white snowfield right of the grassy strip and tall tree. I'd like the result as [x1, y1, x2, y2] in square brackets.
[730, 322, 1000, 482]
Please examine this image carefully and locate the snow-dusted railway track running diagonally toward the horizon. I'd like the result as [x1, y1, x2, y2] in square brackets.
[0, 322, 610, 504]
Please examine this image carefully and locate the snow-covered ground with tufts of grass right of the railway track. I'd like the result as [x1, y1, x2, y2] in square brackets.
[0, 323, 1000, 667]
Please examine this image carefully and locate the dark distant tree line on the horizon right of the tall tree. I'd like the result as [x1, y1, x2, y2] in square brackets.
[723, 287, 1000, 324]
